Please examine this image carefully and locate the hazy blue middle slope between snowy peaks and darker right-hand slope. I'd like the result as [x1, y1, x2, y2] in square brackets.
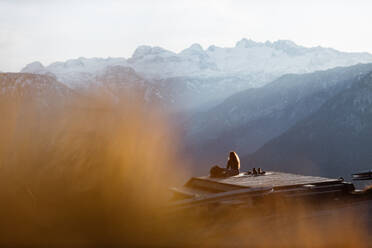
[185, 64, 372, 165]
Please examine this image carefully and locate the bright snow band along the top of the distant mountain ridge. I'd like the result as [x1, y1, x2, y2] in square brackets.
[22, 39, 372, 83]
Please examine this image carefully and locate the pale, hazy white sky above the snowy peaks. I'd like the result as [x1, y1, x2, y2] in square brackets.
[0, 0, 372, 71]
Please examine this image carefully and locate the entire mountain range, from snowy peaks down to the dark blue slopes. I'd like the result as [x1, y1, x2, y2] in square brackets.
[0, 39, 372, 176]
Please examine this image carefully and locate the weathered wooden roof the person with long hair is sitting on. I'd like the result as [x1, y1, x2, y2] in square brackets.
[172, 171, 355, 210]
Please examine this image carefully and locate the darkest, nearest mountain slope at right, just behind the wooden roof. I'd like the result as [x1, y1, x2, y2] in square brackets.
[243, 72, 372, 177]
